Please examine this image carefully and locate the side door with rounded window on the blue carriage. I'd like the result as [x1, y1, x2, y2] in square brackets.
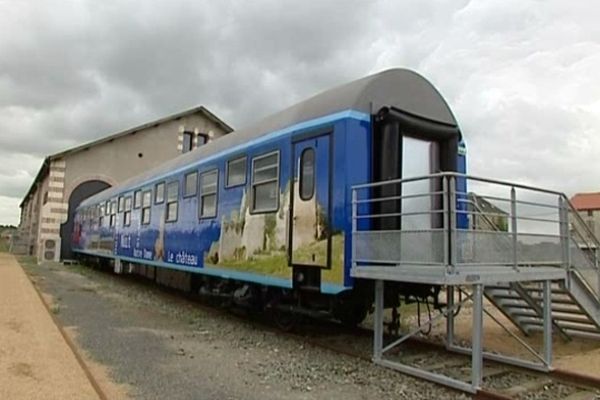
[289, 135, 331, 267]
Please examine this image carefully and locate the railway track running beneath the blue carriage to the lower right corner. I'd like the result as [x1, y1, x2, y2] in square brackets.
[72, 262, 600, 400]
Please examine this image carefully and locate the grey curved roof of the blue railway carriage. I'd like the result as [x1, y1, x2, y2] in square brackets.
[81, 68, 457, 206]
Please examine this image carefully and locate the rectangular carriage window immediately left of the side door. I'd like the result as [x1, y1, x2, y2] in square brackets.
[251, 152, 279, 212]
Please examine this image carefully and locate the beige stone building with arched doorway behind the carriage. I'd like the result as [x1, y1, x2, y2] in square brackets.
[13, 106, 232, 261]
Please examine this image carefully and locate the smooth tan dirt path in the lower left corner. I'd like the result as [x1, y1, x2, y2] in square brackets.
[0, 253, 99, 400]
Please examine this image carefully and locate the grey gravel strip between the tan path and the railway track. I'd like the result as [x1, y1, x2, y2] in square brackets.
[19, 263, 469, 400]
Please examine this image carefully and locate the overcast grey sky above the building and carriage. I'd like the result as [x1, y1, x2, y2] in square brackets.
[0, 0, 600, 224]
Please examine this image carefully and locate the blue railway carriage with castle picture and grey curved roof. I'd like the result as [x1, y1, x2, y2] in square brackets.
[72, 69, 465, 323]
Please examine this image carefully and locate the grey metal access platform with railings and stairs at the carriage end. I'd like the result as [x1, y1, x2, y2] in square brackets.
[352, 173, 600, 393]
